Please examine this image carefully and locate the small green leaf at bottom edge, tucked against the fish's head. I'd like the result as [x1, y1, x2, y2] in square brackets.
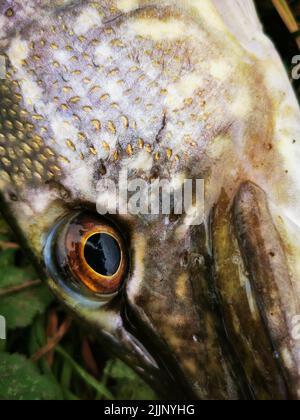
[104, 360, 158, 401]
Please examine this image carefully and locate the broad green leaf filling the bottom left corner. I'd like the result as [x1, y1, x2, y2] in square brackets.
[0, 353, 63, 401]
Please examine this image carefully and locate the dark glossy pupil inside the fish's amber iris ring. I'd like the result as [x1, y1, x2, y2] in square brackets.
[84, 233, 121, 277]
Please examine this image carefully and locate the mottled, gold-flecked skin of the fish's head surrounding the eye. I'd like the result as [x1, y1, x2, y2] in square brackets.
[0, 0, 300, 399]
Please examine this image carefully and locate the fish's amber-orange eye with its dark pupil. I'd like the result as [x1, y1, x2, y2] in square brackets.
[46, 212, 128, 295]
